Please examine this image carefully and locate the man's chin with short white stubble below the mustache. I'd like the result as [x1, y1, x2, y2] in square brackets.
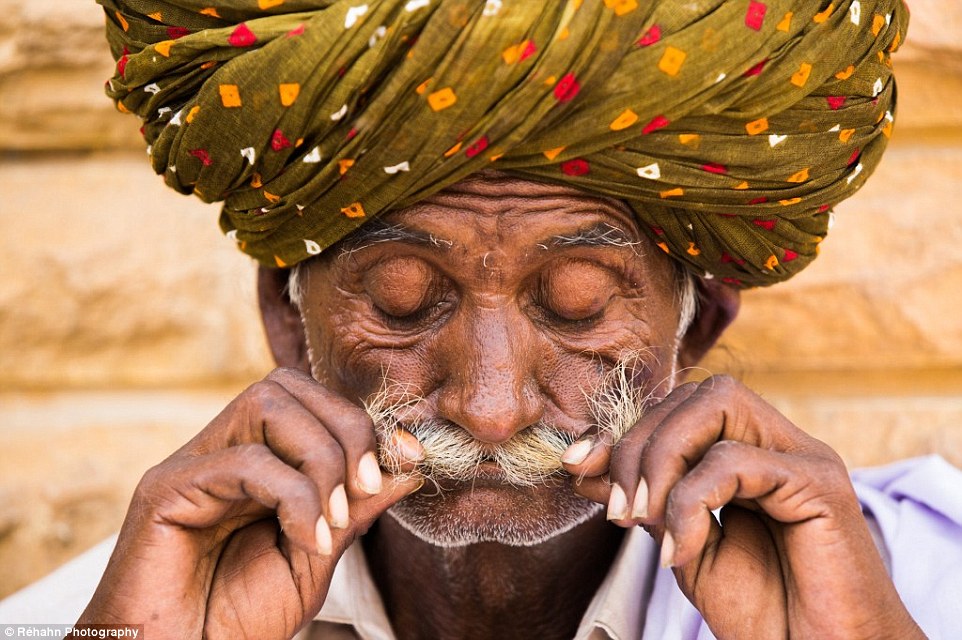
[388, 479, 603, 547]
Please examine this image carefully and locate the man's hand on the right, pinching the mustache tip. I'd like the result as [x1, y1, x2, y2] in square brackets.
[566, 377, 924, 638]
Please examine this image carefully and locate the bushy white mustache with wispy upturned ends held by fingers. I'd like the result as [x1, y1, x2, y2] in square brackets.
[365, 354, 650, 487]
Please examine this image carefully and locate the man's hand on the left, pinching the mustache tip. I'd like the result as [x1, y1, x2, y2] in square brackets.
[80, 369, 423, 640]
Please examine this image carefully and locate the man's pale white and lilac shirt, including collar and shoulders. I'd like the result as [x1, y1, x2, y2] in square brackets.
[0, 456, 962, 640]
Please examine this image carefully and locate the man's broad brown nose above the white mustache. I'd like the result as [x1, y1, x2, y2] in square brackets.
[438, 308, 544, 444]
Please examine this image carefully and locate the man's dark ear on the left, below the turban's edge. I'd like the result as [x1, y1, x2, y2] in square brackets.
[257, 267, 311, 373]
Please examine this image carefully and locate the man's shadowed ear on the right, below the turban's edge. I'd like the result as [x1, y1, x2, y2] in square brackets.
[678, 278, 741, 368]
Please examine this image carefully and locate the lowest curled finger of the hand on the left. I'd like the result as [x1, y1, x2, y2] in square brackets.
[155, 444, 331, 553]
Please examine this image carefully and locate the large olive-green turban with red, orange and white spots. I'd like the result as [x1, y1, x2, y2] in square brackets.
[98, 0, 908, 286]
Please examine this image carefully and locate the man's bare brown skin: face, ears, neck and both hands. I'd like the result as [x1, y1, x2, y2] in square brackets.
[82, 176, 921, 639]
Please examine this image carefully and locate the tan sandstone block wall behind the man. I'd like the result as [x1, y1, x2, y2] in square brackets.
[0, 0, 962, 596]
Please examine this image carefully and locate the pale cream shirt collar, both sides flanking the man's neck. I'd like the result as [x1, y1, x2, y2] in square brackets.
[314, 527, 658, 640]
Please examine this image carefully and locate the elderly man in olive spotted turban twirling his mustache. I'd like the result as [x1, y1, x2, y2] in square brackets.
[9, 0, 962, 638]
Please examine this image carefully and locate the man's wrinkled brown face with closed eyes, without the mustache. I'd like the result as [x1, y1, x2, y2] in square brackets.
[300, 176, 679, 545]
